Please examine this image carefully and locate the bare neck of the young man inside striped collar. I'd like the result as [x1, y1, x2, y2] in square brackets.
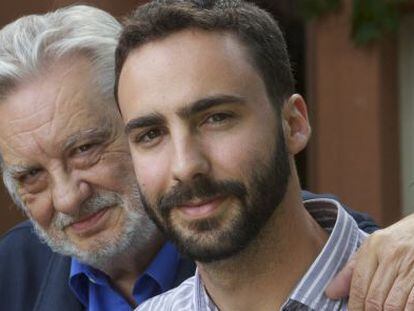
[197, 177, 328, 311]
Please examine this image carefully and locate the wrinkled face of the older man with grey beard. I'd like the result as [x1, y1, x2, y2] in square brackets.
[0, 56, 154, 264]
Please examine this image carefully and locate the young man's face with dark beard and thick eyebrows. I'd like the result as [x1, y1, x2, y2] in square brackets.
[118, 30, 289, 261]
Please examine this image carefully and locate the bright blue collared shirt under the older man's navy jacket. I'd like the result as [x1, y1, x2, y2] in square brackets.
[69, 242, 180, 311]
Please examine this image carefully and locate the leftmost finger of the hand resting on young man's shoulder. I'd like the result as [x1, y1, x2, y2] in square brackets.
[325, 254, 356, 300]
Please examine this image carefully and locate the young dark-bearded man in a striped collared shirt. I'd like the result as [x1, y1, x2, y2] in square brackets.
[115, 0, 413, 311]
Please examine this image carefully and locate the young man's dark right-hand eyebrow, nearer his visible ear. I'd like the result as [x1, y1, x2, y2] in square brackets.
[177, 95, 246, 119]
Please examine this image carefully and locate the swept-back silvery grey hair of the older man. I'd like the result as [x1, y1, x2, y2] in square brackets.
[0, 5, 122, 212]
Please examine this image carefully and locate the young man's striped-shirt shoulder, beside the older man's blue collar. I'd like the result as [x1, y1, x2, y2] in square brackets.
[136, 276, 196, 311]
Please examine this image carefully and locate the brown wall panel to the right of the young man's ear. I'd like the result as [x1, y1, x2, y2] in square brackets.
[307, 0, 401, 224]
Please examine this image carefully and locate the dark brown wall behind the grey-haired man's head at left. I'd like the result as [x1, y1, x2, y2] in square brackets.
[0, 0, 145, 235]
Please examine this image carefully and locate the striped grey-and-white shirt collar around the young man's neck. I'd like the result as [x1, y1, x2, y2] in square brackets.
[193, 199, 366, 311]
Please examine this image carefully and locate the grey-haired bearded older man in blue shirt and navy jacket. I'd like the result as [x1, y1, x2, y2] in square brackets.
[0, 2, 412, 311]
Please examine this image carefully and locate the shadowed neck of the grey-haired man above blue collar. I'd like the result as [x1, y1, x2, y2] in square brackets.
[101, 231, 165, 307]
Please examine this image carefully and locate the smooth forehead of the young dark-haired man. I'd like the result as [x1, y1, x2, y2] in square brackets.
[118, 29, 265, 118]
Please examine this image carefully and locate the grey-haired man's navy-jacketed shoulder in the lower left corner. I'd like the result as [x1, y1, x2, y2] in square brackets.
[0, 221, 74, 311]
